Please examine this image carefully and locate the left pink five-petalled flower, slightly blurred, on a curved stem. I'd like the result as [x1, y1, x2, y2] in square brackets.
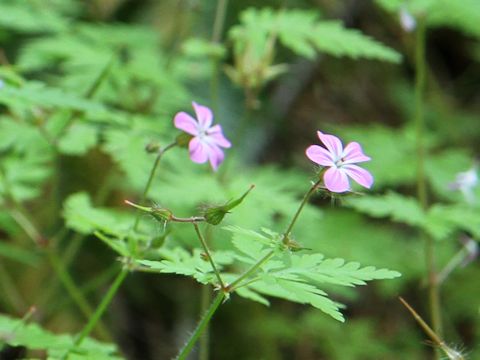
[173, 102, 232, 170]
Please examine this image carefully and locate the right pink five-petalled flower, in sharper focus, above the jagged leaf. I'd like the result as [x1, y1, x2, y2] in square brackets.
[305, 131, 373, 193]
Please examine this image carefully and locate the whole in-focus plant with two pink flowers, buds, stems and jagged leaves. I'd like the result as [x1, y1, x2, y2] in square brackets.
[54, 102, 400, 359]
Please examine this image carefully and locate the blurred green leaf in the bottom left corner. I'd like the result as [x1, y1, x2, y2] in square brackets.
[0, 315, 120, 359]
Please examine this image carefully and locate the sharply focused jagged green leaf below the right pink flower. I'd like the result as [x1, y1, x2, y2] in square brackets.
[225, 226, 400, 321]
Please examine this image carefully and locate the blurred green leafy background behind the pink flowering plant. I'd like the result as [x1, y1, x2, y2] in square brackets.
[0, 0, 480, 360]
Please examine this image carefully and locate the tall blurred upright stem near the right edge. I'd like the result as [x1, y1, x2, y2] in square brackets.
[415, 17, 442, 344]
